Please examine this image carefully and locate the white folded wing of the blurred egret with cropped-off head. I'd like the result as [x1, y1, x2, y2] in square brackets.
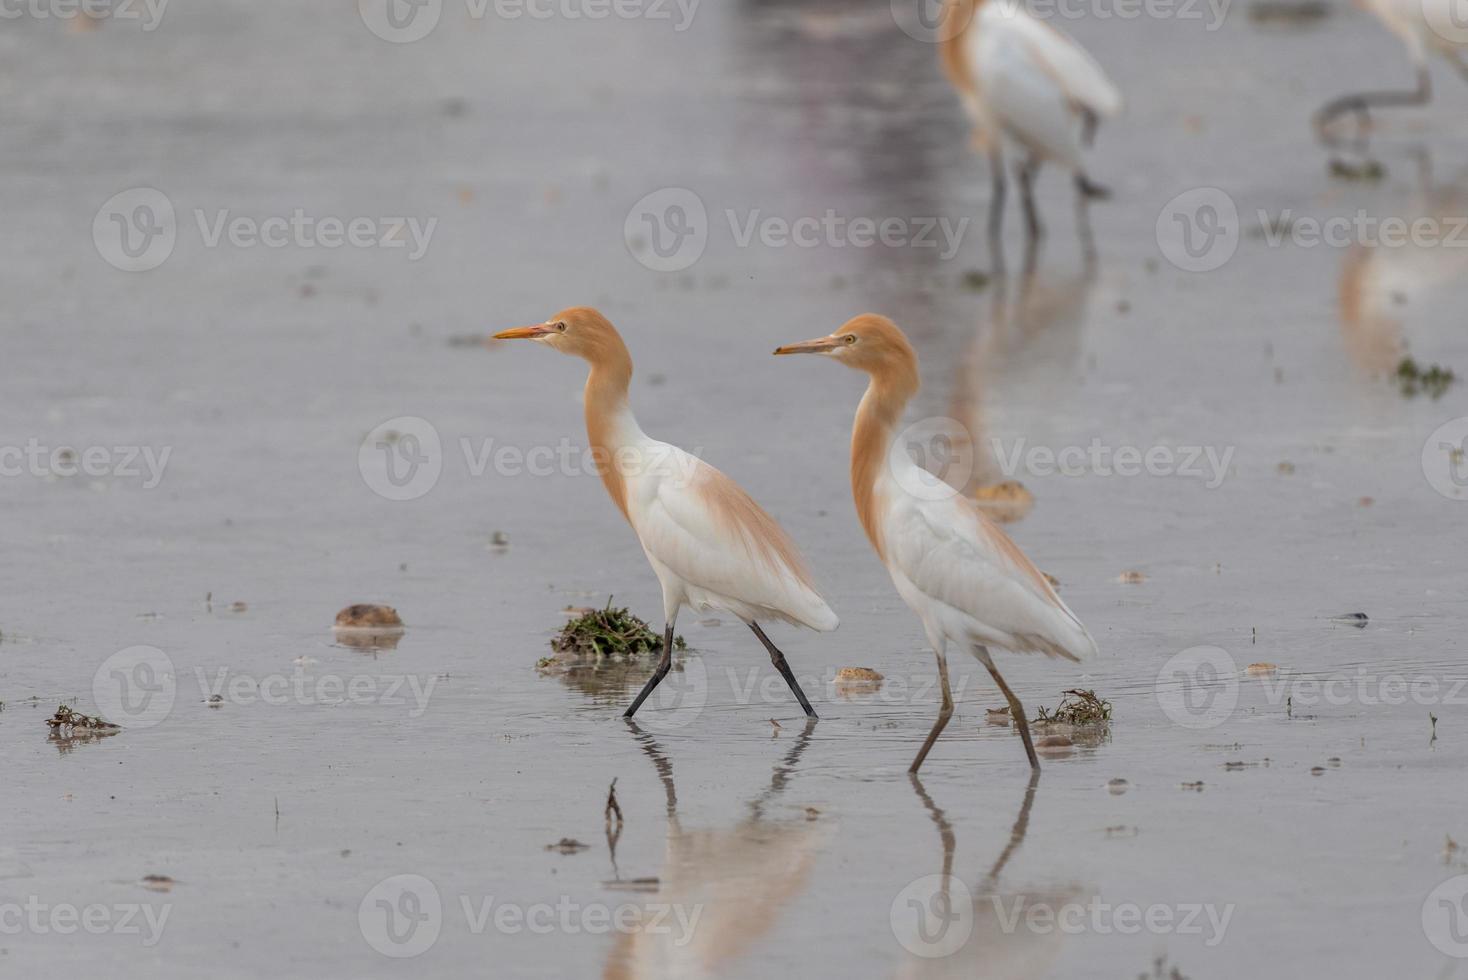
[966, 0, 1122, 169]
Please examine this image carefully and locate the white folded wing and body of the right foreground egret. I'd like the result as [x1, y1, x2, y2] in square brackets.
[882, 493, 1097, 660]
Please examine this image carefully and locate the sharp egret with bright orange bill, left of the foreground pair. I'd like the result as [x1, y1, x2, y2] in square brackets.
[495, 307, 838, 717]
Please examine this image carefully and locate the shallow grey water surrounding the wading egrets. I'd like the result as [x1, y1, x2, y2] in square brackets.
[0, 0, 1468, 979]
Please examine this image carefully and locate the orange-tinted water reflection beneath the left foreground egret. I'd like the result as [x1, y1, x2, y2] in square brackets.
[602, 720, 825, 980]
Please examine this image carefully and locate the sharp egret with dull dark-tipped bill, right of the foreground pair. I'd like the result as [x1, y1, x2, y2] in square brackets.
[775, 314, 1097, 772]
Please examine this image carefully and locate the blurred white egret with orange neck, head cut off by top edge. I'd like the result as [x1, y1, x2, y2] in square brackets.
[938, 0, 1122, 254]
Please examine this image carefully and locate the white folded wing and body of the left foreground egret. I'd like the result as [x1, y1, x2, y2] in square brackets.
[628, 443, 838, 631]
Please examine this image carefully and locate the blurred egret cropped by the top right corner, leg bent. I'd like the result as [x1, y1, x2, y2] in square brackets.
[1315, 0, 1468, 136]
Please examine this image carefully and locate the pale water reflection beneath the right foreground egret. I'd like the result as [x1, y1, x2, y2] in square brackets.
[893, 772, 1079, 980]
